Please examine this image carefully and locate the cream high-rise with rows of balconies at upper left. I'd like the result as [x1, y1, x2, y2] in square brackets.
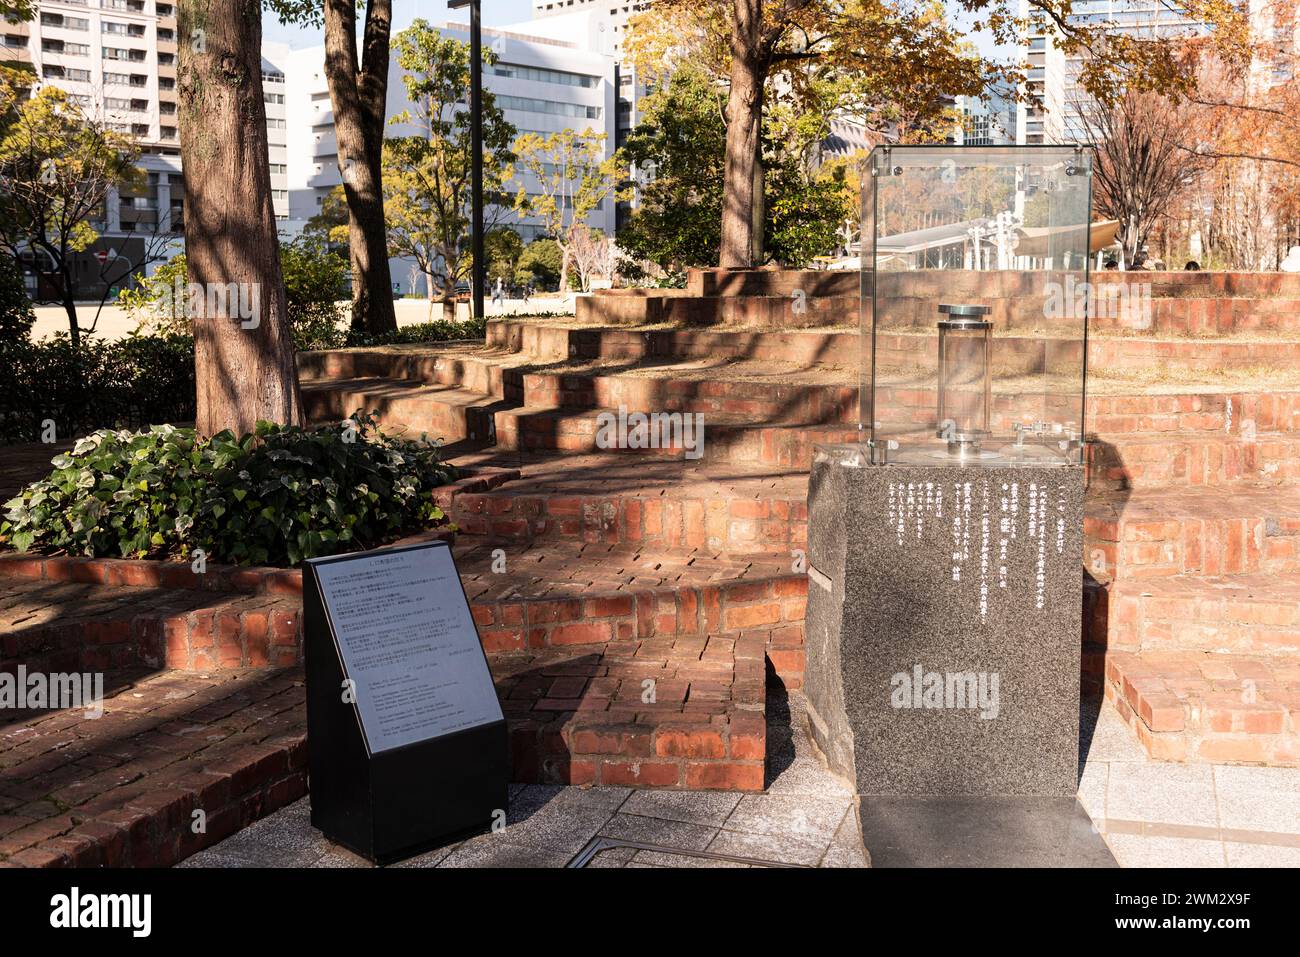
[0, 0, 289, 299]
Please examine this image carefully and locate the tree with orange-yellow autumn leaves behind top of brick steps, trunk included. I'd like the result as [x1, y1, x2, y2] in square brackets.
[628, 0, 1245, 267]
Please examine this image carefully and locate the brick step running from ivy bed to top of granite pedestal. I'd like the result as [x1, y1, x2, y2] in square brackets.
[451, 452, 807, 554]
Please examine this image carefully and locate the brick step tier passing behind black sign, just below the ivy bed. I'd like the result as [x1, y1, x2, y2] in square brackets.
[0, 537, 807, 685]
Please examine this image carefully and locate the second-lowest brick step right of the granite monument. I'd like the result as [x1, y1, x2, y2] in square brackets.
[1084, 572, 1300, 661]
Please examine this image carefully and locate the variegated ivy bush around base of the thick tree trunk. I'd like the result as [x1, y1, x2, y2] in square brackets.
[0, 415, 454, 564]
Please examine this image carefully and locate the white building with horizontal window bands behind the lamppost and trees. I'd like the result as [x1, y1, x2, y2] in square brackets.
[287, 23, 615, 294]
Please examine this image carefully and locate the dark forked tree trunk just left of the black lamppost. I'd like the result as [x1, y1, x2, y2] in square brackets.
[325, 0, 398, 333]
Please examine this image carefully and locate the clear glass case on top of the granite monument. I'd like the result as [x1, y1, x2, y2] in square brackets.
[859, 146, 1096, 467]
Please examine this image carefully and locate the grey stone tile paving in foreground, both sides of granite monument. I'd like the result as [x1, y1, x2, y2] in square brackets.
[181, 693, 1300, 867]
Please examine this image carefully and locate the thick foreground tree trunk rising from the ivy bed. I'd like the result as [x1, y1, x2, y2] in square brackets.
[178, 0, 303, 436]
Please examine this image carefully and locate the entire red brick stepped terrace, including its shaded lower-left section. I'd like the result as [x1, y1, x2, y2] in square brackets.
[0, 270, 1300, 866]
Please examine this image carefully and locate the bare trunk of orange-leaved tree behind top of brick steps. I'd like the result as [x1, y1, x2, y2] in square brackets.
[718, 0, 767, 268]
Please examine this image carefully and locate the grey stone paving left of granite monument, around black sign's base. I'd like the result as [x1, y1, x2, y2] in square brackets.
[181, 697, 867, 867]
